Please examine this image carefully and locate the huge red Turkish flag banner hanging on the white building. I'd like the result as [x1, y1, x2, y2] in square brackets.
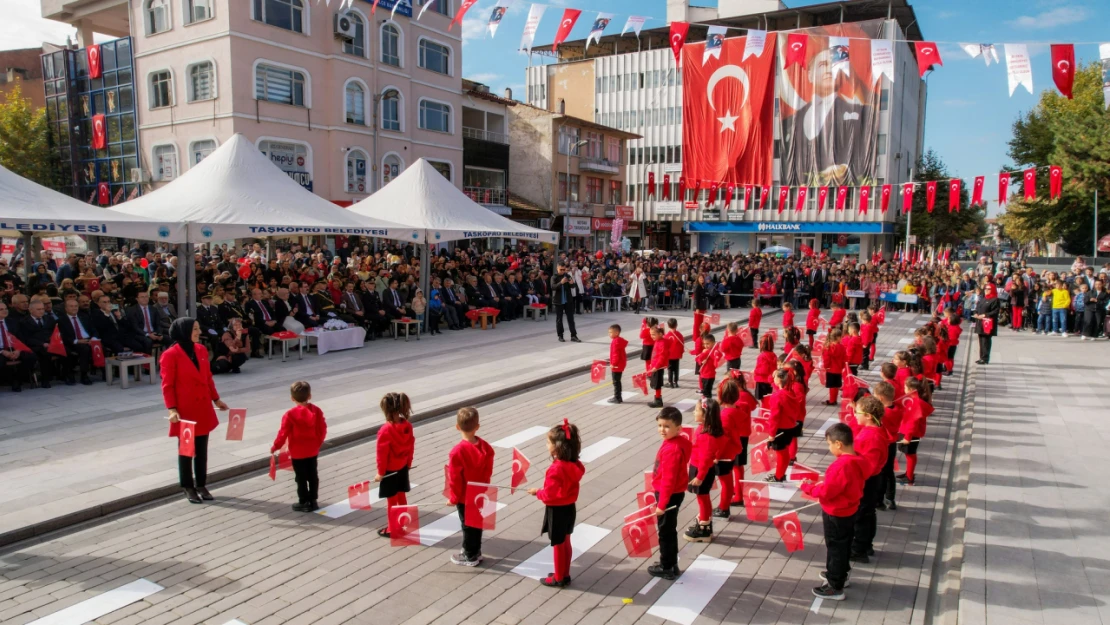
[683, 33, 776, 187]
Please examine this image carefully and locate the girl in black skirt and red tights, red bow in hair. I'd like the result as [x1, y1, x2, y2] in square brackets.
[528, 419, 586, 588]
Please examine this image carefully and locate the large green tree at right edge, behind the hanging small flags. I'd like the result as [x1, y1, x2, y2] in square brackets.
[1003, 63, 1110, 254]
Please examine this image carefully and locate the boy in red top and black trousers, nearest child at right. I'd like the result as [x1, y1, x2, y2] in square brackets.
[801, 423, 867, 601]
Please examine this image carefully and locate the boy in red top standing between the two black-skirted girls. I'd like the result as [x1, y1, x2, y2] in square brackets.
[447, 406, 494, 566]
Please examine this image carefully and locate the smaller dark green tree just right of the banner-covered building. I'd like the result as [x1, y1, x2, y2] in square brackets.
[899, 150, 987, 246]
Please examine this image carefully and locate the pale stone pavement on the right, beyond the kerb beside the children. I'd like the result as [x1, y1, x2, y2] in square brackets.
[959, 331, 1110, 625]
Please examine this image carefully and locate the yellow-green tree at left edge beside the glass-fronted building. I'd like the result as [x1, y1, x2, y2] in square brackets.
[0, 83, 58, 187]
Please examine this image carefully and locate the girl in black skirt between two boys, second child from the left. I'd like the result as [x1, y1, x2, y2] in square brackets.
[374, 393, 416, 538]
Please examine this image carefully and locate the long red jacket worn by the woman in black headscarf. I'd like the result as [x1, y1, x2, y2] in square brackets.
[158, 343, 220, 436]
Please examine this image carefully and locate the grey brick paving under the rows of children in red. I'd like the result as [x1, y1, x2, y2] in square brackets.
[0, 314, 962, 625]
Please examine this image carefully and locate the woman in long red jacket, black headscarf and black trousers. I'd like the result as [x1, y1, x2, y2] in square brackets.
[159, 316, 228, 504]
